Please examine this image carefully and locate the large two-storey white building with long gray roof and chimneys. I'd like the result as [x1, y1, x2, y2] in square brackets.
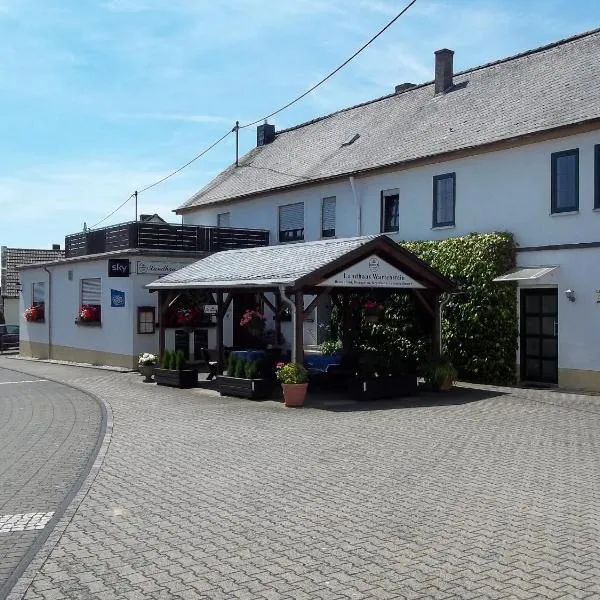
[176, 30, 600, 390]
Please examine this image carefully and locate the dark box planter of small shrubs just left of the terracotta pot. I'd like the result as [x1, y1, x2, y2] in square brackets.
[218, 353, 273, 400]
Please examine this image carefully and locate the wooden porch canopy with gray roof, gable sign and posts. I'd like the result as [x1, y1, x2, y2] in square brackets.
[146, 235, 455, 365]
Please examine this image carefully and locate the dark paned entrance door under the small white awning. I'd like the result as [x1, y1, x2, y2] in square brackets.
[521, 289, 558, 383]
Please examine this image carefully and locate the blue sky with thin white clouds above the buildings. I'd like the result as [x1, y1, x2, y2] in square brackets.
[0, 0, 600, 247]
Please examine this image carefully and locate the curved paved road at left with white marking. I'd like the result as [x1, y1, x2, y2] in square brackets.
[0, 361, 101, 598]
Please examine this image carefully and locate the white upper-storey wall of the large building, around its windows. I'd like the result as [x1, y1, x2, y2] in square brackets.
[183, 130, 600, 246]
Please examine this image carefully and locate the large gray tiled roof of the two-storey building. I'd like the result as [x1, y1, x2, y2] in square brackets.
[178, 30, 600, 210]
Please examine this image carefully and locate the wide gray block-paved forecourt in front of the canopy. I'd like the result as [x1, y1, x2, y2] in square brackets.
[0, 361, 600, 600]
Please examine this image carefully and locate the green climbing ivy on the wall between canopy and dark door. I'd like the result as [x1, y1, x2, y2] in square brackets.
[404, 233, 518, 385]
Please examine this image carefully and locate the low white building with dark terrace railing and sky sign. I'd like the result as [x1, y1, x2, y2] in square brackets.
[19, 220, 268, 368]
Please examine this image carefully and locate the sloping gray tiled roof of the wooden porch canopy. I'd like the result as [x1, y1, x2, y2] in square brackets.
[146, 236, 378, 289]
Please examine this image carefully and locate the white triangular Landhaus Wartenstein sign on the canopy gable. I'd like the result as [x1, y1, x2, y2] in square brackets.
[319, 256, 425, 289]
